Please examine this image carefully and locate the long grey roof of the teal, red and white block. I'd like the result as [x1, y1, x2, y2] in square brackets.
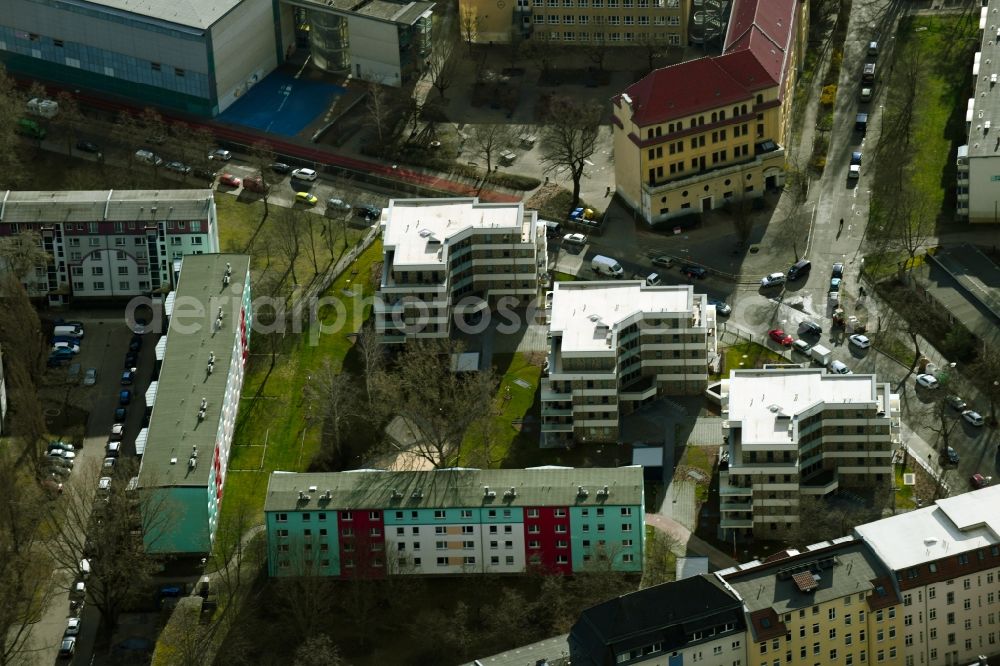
[264, 466, 643, 511]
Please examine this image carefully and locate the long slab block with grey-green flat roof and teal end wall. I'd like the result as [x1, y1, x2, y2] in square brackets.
[136, 254, 253, 555]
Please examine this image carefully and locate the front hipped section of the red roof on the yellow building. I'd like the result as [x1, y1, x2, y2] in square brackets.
[625, 58, 749, 125]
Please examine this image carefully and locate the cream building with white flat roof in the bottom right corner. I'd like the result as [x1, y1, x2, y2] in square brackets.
[854, 486, 1000, 666]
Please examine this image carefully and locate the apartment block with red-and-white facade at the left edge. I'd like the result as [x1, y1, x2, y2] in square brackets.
[0, 190, 219, 305]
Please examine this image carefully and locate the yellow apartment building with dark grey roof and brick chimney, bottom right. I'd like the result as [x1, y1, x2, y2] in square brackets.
[716, 537, 903, 666]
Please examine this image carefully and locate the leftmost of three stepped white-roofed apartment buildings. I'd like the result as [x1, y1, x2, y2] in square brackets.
[375, 198, 547, 343]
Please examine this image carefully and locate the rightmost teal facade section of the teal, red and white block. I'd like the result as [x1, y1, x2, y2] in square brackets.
[569, 505, 645, 571]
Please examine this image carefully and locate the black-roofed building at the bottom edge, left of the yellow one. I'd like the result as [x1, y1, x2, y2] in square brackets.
[569, 574, 747, 666]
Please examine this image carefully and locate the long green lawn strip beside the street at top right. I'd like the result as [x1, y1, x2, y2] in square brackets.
[889, 14, 978, 218]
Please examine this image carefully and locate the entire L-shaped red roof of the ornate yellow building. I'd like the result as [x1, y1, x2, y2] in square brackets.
[614, 0, 799, 126]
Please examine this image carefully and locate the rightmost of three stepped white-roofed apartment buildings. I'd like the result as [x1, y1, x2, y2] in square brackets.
[719, 368, 899, 538]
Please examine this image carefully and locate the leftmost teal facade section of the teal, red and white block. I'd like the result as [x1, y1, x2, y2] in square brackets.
[264, 511, 340, 577]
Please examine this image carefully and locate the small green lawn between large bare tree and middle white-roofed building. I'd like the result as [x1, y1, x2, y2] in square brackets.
[459, 354, 542, 467]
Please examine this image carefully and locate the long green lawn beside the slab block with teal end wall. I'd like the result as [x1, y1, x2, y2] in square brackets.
[223, 240, 382, 536]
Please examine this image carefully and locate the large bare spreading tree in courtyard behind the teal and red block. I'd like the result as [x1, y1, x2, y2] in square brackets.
[379, 339, 496, 467]
